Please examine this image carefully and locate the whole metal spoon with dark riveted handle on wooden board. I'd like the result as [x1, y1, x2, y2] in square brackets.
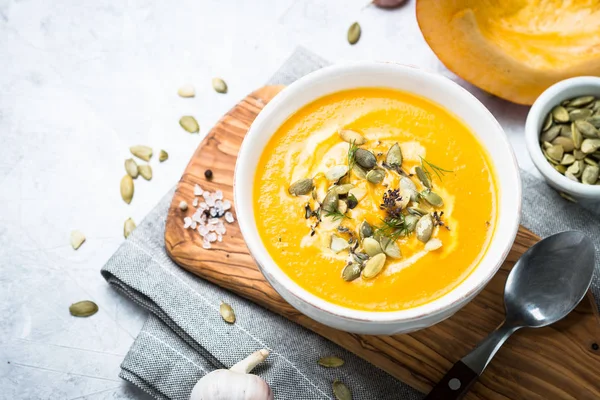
[425, 232, 595, 400]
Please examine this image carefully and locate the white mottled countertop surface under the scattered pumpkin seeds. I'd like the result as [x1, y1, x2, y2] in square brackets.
[0, 0, 533, 400]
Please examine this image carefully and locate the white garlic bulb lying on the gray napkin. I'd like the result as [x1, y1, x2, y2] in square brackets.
[190, 349, 274, 400]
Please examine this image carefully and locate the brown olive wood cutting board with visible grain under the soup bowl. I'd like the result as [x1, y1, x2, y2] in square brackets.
[165, 86, 600, 400]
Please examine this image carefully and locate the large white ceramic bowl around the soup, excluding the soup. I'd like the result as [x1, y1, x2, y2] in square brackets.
[234, 62, 521, 334]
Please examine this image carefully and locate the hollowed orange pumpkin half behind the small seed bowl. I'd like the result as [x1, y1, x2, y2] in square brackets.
[416, 0, 600, 104]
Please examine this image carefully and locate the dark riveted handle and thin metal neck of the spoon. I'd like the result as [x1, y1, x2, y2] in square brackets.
[425, 322, 518, 400]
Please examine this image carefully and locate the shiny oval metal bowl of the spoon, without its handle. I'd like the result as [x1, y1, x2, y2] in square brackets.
[504, 231, 595, 328]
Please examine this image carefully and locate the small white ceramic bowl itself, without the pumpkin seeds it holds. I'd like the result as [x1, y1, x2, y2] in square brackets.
[525, 76, 600, 209]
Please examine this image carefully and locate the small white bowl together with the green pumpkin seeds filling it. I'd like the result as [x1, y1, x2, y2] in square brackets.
[525, 76, 600, 209]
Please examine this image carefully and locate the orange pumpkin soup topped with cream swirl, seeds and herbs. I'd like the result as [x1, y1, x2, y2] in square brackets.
[253, 88, 497, 311]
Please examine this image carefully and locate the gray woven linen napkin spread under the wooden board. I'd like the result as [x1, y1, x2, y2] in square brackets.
[102, 48, 600, 400]
